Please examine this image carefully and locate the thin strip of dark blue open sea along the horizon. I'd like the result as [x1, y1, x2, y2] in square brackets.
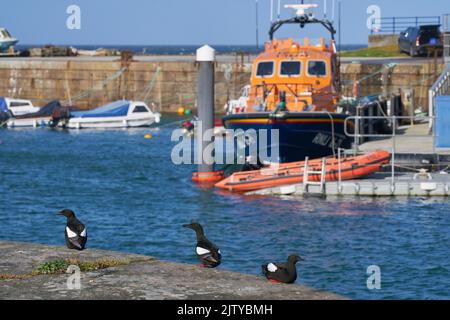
[16, 44, 367, 55]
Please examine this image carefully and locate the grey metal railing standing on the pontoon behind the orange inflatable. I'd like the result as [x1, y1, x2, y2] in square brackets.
[344, 116, 436, 186]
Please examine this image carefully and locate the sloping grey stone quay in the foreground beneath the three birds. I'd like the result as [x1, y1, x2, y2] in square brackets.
[0, 241, 342, 300]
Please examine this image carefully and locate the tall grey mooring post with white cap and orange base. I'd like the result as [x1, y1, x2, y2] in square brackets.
[192, 45, 223, 183]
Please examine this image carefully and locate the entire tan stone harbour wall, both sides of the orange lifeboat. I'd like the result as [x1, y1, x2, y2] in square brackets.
[0, 58, 444, 112]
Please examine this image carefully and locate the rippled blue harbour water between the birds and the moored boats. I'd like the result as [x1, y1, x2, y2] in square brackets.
[0, 117, 450, 299]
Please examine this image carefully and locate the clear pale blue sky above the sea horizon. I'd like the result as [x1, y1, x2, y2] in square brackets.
[0, 0, 450, 45]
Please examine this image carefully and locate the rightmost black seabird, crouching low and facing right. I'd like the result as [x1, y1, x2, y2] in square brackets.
[262, 255, 304, 284]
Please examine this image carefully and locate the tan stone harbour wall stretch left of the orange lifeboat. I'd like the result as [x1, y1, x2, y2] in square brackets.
[0, 59, 251, 112]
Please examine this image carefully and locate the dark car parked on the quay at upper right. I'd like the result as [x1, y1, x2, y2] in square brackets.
[398, 25, 443, 57]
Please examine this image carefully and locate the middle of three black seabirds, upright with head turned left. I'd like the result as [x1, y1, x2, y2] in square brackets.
[183, 222, 222, 268]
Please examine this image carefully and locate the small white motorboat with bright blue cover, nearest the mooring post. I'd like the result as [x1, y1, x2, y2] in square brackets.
[65, 100, 161, 129]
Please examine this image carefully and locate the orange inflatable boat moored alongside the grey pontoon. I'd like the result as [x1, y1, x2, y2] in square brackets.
[216, 150, 391, 192]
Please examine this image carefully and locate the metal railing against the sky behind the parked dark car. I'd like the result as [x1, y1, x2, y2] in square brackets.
[371, 16, 441, 34]
